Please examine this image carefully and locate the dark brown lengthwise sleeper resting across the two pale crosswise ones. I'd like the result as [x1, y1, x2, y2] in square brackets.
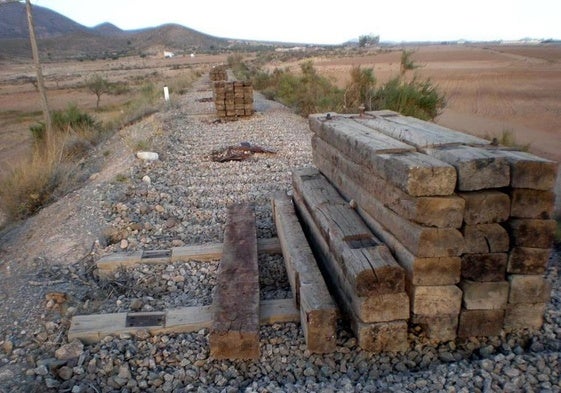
[209, 204, 259, 359]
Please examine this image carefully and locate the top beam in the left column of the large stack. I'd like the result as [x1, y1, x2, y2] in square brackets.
[310, 115, 457, 196]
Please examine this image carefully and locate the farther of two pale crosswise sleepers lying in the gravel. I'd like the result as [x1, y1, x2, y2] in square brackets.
[96, 237, 282, 276]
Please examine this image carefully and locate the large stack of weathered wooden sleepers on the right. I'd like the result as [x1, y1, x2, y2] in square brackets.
[309, 111, 557, 341]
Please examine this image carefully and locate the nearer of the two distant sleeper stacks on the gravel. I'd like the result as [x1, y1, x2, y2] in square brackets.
[213, 81, 253, 118]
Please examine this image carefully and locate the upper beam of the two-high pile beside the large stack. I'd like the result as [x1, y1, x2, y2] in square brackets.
[292, 169, 405, 296]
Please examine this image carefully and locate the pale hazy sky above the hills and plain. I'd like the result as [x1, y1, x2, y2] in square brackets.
[32, 0, 561, 44]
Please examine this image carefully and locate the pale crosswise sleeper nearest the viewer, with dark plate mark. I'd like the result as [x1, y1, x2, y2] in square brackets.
[68, 299, 300, 344]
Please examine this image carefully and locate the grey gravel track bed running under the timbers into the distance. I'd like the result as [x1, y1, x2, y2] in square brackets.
[0, 75, 561, 393]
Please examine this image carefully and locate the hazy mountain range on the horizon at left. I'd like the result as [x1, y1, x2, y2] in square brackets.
[0, 2, 243, 60]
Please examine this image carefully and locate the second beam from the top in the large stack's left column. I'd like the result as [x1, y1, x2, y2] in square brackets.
[312, 136, 465, 228]
